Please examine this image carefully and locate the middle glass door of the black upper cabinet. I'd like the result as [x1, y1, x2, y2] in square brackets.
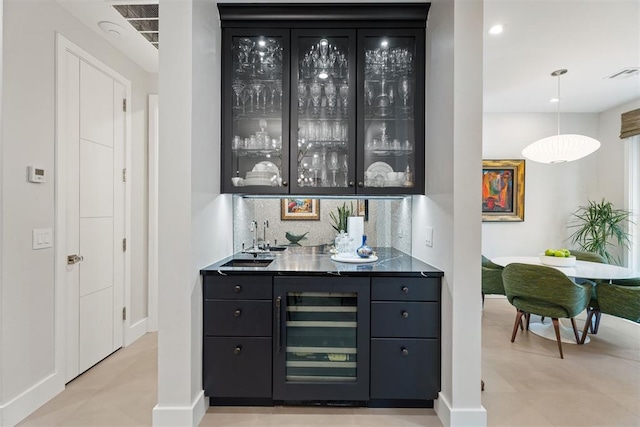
[291, 30, 356, 194]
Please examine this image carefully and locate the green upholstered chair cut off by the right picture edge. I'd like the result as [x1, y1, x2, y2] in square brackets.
[583, 277, 640, 341]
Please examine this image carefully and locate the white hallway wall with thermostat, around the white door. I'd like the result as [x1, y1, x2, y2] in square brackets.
[0, 0, 155, 425]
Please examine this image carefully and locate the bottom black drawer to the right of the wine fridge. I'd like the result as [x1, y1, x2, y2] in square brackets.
[371, 339, 440, 399]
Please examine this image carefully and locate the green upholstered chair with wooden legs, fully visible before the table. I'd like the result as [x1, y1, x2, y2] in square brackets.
[502, 263, 591, 359]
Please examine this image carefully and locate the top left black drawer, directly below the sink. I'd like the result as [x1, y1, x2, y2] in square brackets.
[204, 276, 272, 300]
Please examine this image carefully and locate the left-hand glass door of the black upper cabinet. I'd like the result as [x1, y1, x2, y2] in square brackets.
[222, 30, 289, 193]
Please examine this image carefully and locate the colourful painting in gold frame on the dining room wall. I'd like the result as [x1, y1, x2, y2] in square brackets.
[482, 159, 525, 222]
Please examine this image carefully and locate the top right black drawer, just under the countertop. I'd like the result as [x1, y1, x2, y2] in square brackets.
[371, 277, 440, 301]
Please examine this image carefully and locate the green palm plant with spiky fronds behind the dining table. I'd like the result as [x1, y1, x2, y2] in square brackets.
[569, 199, 633, 264]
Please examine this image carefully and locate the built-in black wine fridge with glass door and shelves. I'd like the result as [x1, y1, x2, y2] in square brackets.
[273, 277, 370, 401]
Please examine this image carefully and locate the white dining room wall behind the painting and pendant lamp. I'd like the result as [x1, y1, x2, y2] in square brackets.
[482, 113, 604, 257]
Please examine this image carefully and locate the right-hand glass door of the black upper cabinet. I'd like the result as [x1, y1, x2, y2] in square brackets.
[358, 30, 425, 193]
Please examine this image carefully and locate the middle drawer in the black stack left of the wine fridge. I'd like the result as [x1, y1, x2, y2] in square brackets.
[204, 300, 273, 337]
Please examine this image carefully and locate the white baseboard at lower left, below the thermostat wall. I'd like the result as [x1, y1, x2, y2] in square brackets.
[0, 372, 64, 427]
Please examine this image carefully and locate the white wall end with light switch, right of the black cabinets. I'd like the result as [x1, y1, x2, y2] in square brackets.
[412, 0, 487, 426]
